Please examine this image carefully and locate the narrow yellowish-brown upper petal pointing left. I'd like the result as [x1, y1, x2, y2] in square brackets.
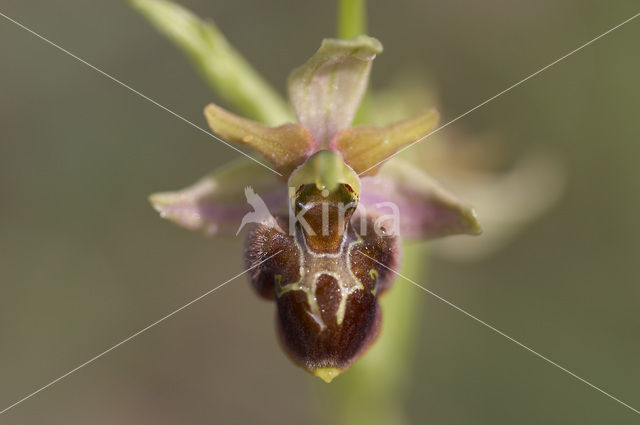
[204, 104, 316, 177]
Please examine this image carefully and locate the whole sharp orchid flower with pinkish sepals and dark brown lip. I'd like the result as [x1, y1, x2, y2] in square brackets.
[151, 36, 480, 381]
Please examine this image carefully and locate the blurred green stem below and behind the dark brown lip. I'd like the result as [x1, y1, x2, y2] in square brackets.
[321, 243, 428, 425]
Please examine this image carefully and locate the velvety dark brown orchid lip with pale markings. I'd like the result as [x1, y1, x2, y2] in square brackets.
[246, 185, 398, 381]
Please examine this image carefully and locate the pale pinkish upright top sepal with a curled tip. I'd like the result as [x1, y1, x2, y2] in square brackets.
[289, 36, 382, 147]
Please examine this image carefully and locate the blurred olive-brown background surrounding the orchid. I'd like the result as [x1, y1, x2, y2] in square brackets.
[0, 0, 640, 425]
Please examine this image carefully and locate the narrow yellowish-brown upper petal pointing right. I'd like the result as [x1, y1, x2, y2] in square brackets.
[331, 109, 440, 175]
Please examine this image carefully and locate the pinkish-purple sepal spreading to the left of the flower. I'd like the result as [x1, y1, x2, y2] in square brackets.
[149, 159, 287, 235]
